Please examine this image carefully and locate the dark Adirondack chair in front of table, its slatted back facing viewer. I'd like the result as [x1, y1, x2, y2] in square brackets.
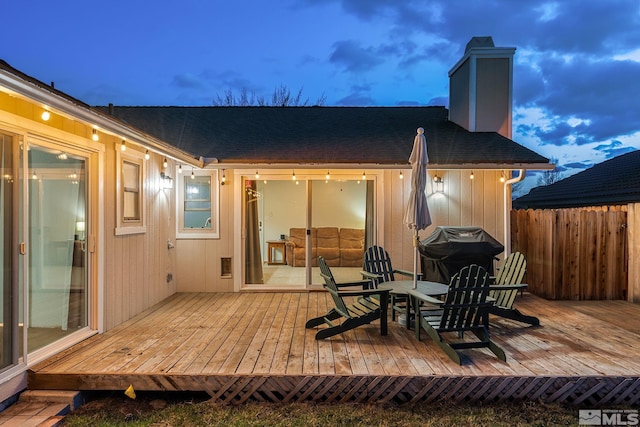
[409, 264, 507, 364]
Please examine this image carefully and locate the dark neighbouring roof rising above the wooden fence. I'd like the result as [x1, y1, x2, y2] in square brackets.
[513, 151, 640, 209]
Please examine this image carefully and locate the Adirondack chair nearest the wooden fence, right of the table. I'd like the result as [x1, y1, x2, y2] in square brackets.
[489, 252, 540, 326]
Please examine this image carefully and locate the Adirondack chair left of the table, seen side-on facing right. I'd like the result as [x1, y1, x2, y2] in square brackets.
[305, 256, 389, 340]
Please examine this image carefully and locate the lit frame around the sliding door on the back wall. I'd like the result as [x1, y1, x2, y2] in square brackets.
[236, 167, 385, 292]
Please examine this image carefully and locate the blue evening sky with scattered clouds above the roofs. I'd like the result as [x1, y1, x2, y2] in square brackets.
[0, 0, 640, 196]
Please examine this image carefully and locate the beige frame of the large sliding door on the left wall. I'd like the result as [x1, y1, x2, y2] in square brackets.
[0, 116, 105, 390]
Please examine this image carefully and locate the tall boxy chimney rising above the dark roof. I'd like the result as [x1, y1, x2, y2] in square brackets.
[449, 37, 516, 138]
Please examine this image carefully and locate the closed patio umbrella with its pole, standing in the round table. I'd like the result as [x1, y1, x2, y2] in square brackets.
[404, 128, 431, 289]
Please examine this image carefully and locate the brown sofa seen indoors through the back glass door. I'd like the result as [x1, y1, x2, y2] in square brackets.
[285, 227, 364, 267]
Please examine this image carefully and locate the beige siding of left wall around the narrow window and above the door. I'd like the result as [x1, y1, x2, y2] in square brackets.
[0, 91, 176, 330]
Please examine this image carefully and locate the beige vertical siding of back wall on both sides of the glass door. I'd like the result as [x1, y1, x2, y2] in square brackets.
[175, 169, 510, 292]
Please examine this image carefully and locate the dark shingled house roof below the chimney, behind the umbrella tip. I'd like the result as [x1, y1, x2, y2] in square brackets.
[97, 106, 549, 168]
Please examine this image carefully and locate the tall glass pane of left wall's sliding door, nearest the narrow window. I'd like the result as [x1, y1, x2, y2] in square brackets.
[26, 144, 88, 352]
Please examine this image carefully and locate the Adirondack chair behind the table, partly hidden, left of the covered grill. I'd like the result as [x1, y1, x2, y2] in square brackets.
[360, 246, 422, 320]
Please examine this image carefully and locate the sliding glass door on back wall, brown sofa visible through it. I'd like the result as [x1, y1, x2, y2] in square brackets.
[242, 170, 376, 289]
